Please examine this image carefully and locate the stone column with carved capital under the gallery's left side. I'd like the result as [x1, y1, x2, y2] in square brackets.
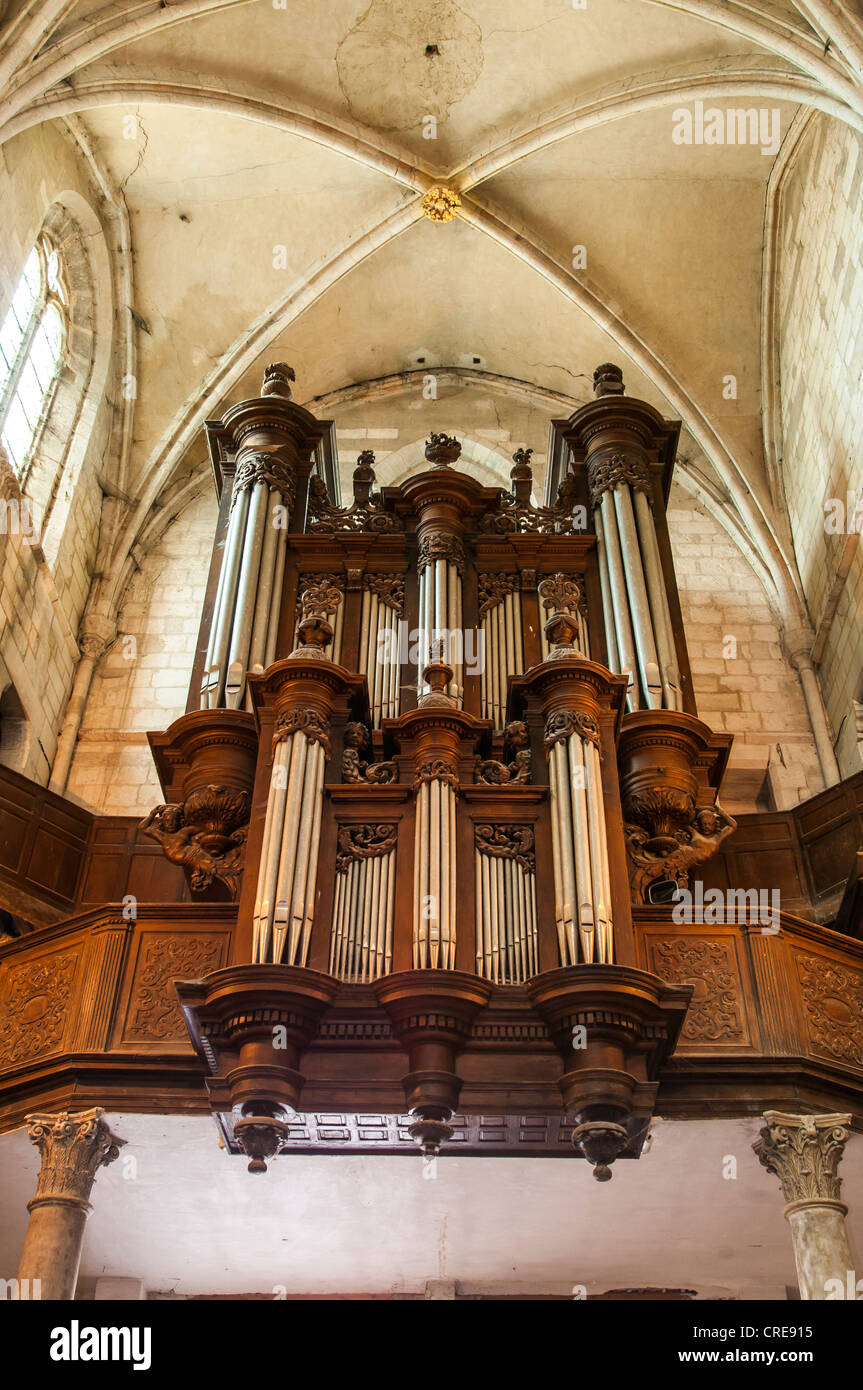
[18, 1109, 125, 1300]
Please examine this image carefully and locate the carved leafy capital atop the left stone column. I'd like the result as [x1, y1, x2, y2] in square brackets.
[26, 1108, 125, 1207]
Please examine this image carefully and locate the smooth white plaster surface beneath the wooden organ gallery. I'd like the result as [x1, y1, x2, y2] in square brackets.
[0, 1115, 863, 1300]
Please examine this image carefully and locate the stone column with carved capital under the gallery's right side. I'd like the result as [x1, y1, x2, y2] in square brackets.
[752, 1111, 853, 1300]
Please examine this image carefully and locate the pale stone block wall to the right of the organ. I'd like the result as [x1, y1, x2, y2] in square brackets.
[778, 115, 863, 777]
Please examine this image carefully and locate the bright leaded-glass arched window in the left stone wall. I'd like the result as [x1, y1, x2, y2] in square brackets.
[0, 235, 69, 478]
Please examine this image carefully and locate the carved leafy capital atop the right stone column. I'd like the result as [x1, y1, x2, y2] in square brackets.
[752, 1111, 852, 1202]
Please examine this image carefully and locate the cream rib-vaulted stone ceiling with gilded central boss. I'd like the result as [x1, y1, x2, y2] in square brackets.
[0, 0, 863, 622]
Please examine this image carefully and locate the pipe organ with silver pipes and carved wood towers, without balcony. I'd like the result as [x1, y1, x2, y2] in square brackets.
[147, 364, 732, 1176]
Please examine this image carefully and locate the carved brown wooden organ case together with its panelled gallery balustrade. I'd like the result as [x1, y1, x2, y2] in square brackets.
[0, 364, 863, 1180]
